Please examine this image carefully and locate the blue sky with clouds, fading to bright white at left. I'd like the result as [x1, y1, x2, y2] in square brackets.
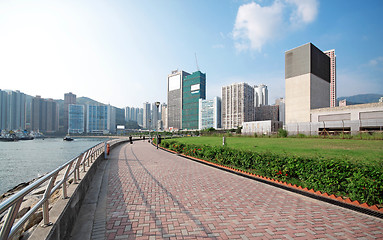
[0, 0, 383, 107]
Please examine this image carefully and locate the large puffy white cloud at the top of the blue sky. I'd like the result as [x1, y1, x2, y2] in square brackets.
[233, 0, 319, 51]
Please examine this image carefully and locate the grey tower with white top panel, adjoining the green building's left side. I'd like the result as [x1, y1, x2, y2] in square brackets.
[168, 70, 190, 129]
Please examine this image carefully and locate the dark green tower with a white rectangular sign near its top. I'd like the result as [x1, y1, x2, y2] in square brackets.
[182, 71, 206, 129]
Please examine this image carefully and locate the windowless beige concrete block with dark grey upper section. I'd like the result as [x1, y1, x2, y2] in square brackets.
[285, 43, 330, 124]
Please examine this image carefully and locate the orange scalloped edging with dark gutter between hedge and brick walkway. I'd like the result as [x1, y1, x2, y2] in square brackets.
[156, 144, 383, 219]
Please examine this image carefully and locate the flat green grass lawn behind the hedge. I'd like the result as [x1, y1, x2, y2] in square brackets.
[169, 137, 383, 166]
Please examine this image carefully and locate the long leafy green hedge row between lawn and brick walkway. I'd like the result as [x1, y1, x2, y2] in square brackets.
[161, 140, 383, 205]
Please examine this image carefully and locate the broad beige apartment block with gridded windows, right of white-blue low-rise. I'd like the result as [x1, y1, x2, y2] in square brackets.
[222, 83, 254, 129]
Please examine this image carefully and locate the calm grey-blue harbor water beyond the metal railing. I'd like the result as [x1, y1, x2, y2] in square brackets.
[0, 138, 106, 195]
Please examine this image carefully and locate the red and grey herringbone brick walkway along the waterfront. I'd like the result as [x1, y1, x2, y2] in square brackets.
[92, 141, 383, 239]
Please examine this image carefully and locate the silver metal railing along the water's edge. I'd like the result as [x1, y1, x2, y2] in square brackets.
[0, 139, 123, 240]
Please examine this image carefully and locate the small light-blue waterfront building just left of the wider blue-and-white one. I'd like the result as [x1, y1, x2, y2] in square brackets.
[68, 104, 85, 134]
